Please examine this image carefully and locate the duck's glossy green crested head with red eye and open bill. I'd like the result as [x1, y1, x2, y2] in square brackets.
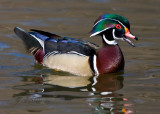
[90, 14, 138, 46]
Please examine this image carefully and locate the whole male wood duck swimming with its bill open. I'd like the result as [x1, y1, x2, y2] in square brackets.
[14, 14, 138, 76]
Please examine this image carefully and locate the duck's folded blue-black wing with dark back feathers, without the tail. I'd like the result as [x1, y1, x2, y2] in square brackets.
[30, 29, 99, 56]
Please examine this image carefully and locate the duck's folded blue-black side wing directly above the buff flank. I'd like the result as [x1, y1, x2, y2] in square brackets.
[44, 37, 95, 56]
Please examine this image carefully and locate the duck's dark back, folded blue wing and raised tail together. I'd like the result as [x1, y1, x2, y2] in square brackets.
[14, 27, 98, 56]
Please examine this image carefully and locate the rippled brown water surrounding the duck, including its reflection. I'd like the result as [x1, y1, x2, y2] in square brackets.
[0, 0, 160, 114]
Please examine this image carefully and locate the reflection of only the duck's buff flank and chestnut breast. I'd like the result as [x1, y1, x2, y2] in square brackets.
[43, 74, 123, 92]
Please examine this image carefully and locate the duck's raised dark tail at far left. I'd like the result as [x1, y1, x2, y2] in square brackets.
[14, 27, 42, 54]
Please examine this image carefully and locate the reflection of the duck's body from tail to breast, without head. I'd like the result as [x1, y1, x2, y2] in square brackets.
[15, 72, 123, 95]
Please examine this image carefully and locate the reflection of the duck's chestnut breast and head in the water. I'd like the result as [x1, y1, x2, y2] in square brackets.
[87, 74, 132, 114]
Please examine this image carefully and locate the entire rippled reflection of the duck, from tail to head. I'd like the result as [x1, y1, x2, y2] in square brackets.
[14, 72, 132, 114]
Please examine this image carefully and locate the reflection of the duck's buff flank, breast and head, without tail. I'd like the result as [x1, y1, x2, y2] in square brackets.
[44, 74, 132, 114]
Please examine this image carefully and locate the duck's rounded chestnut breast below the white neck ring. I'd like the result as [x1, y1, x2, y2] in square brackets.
[97, 45, 124, 74]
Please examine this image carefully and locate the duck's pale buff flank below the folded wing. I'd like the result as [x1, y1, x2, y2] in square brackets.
[43, 53, 93, 76]
